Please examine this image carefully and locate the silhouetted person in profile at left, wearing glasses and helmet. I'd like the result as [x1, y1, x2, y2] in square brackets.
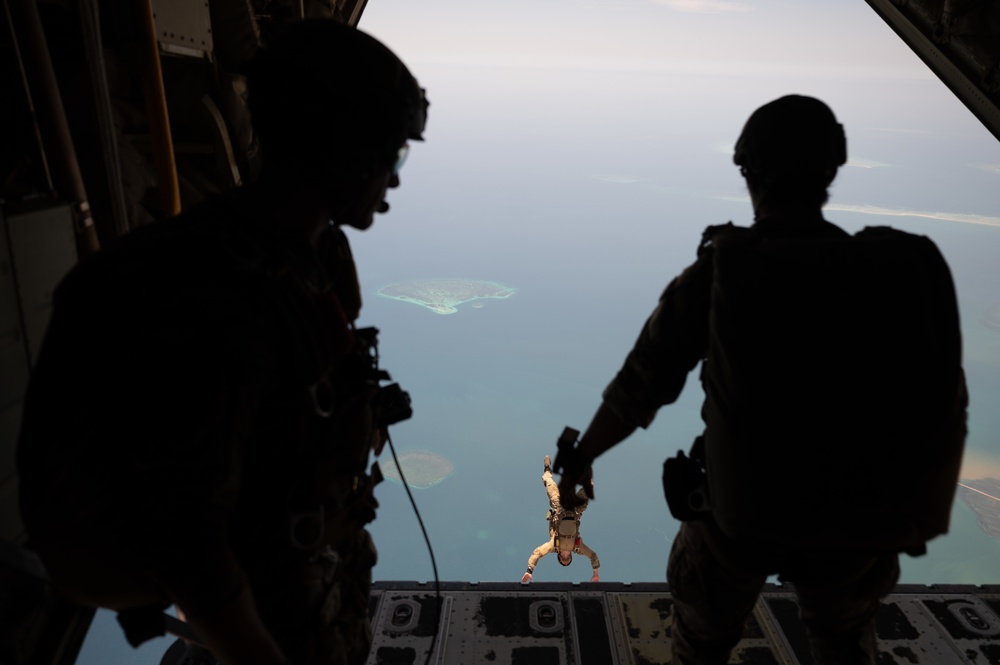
[18, 20, 427, 665]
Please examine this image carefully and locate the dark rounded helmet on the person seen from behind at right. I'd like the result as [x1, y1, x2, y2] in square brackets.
[733, 95, 847, 180]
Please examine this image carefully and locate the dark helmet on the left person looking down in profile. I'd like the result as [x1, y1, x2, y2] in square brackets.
[247, 19, 429, 175]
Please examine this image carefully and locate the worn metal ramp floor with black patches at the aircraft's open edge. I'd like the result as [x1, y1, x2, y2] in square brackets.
[368, 582, 1000, 665]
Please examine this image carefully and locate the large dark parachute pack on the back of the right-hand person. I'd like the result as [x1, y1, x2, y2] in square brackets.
[702, 225, 967, 553]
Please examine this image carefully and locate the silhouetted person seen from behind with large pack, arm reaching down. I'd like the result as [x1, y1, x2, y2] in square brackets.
[554, 95, 967, 665]
